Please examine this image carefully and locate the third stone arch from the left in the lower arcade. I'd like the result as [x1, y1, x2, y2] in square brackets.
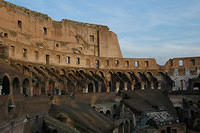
[22, 78, 31, 96]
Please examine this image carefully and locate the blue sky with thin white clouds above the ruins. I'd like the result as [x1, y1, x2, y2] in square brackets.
[7, 0, 200, 64]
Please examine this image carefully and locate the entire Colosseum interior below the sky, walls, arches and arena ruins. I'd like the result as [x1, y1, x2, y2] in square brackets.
[0, 0, 200, 133]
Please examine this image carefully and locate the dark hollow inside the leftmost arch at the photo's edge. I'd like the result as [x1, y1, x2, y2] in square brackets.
[1, 76, 10, 95]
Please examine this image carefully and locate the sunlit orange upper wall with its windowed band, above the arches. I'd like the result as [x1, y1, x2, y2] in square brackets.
[0, 0, 200, 70]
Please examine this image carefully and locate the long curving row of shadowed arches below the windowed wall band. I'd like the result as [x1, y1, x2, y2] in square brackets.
[1, 63, 173, 96]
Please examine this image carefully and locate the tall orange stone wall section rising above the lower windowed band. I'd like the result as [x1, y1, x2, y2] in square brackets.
[0, 0, 122, 58]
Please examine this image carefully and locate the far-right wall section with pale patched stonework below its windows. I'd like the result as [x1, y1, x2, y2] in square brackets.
[165, 57, 200, 90]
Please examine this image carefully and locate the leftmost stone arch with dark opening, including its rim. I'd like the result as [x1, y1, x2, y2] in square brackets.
[1, 74, 11, 95]
